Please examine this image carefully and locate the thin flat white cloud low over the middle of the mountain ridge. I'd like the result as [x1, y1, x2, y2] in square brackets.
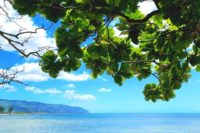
[24, 87, 62, 94]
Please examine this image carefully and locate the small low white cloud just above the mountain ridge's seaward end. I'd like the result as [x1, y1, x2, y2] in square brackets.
[64, 90, 96, 100]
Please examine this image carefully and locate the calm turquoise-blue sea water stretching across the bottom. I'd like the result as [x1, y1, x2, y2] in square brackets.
[0, 114, 200, 133]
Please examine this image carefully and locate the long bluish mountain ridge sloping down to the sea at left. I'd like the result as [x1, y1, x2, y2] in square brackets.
[0, 99, 89, 114]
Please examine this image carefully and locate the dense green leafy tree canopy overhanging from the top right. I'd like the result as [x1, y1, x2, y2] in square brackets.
[12, 0, 200, 101]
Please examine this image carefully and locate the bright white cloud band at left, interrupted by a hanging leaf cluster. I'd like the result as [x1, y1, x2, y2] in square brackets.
[6, 62, 90, 82]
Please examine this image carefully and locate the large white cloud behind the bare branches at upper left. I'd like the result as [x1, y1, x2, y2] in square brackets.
[0, 0, 56, 58]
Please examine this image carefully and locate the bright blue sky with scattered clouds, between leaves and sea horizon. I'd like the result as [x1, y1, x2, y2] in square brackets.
[0, 3, 200, 113]
